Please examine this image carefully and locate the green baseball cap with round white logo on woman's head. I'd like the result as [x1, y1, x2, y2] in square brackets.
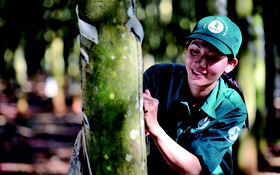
[187, 16, 242, 57]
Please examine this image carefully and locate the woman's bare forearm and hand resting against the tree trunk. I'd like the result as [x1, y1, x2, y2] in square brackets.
[143, 90, 201, 174]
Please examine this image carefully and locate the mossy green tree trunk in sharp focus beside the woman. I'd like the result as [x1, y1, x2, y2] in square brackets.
[69, 0, 147, 175]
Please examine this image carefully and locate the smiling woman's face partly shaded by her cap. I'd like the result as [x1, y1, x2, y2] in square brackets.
[185, 39, 235, 89]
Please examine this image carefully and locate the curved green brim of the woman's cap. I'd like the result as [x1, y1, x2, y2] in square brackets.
[187, 33, 233, 55]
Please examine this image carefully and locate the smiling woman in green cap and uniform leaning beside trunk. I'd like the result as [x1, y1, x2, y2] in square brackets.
[143, 16, 248, 175]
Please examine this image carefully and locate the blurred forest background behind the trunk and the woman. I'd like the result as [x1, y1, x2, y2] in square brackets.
[0, 0, 280, 175]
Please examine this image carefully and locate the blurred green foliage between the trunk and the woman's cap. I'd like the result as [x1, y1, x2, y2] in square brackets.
[137, 0, 196, 62]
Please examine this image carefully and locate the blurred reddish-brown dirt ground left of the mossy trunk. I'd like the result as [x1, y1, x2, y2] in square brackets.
[0, 100, 82, 175]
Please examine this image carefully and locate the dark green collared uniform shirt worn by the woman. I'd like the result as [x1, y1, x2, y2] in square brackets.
[143, 64, 248, 175]
